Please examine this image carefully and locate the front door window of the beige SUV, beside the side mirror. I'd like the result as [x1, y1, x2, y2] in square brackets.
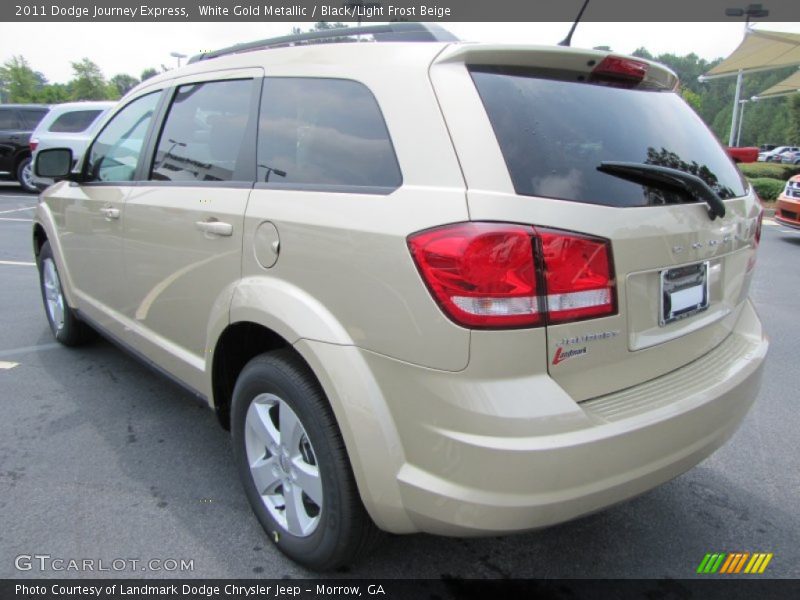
[85, 92, 161, 182]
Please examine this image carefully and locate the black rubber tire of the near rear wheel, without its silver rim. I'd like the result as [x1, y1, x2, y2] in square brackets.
[231, 350, 380, 571]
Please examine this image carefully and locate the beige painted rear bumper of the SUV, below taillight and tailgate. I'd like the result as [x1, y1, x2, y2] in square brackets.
[296, 302, 768, 536]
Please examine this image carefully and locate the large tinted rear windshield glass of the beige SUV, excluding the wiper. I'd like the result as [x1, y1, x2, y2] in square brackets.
[470, 66, 746, 206]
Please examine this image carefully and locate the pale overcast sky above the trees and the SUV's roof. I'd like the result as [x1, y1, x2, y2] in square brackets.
[0, 21, 800, 83]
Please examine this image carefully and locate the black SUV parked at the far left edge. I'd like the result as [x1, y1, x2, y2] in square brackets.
[0, 104, 50, 192]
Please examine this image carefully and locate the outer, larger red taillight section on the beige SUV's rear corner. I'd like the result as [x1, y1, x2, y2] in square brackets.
[408, 223, 541, 327]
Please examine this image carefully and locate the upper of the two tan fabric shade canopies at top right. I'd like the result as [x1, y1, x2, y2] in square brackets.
[702, 29, 800, 79]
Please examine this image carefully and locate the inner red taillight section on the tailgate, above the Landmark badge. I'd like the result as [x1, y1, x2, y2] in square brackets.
[536, 228, 616, 323]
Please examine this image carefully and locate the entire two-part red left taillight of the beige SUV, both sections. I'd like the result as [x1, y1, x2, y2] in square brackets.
[408, 223, 616, 328]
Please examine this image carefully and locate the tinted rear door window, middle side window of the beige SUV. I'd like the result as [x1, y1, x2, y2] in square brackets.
[150, 79, 253, 182]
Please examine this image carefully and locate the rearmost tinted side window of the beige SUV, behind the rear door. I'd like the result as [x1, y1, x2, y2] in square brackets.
[258, 77, 402, 189]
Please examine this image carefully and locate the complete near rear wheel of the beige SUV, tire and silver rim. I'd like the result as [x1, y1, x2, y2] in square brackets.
[231, 350, 380, 571]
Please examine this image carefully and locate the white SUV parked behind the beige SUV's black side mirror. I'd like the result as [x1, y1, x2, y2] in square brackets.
[30, 102, 116, 189]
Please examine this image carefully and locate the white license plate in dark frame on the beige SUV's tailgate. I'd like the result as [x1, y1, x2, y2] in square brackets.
[658, 262, 708, 327]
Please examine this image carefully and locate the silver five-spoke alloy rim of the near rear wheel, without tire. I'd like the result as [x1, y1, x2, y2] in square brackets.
[244, 394, 323, 537]
